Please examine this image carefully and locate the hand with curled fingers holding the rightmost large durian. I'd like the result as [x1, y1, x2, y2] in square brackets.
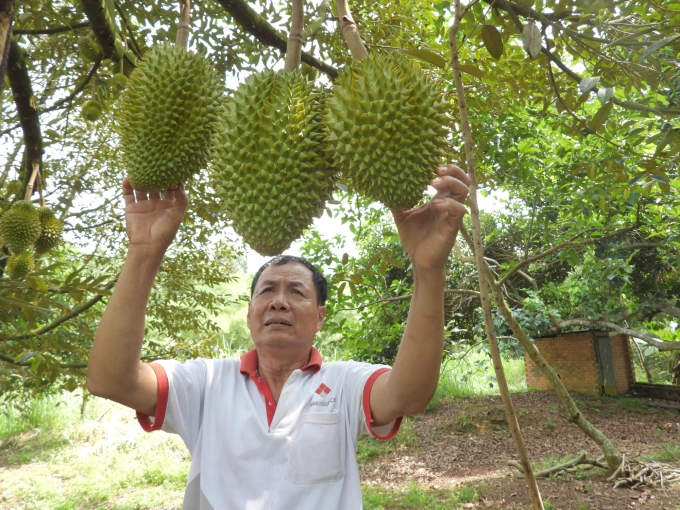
[392, 165, 472, 271]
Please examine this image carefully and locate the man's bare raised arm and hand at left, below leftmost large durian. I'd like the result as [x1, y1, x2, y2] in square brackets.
[87, 179, 187, 416]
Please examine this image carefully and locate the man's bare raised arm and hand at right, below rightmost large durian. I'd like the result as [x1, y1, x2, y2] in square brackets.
[370, 165, 471, 426]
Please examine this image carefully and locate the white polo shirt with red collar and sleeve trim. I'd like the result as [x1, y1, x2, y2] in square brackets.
[137, 348, 401, 510]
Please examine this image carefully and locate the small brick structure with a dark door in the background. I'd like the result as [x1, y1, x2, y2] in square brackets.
[524, 330, 635, 395]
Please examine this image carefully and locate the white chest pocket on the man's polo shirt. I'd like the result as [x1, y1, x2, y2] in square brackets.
[288, 411, 345, 484]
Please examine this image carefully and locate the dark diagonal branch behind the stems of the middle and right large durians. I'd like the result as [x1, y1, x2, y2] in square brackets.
[217, 0, 338, 80]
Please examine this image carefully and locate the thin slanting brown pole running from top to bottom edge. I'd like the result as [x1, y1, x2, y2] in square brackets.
[449, 0, 544, 510]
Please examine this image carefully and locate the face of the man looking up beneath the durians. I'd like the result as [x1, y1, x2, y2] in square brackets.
[248, 263, 326, 349]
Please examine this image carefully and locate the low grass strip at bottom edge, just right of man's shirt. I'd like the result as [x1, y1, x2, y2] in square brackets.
[362, 482, 480, 510]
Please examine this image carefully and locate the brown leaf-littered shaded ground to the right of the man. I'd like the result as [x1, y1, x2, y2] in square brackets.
[360, 392, 680, 510]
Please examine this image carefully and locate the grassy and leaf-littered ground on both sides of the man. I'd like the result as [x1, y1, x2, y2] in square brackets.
[0, 392, 680, 510]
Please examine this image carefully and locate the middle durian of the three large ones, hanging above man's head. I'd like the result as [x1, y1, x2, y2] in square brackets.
[211, 71, 335, 255]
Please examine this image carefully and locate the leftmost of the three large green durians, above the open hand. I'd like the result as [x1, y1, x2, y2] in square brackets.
[117, 44, 224, 191]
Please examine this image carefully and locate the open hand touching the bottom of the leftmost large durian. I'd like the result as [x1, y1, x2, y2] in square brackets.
[123, 177, 189, 253]
